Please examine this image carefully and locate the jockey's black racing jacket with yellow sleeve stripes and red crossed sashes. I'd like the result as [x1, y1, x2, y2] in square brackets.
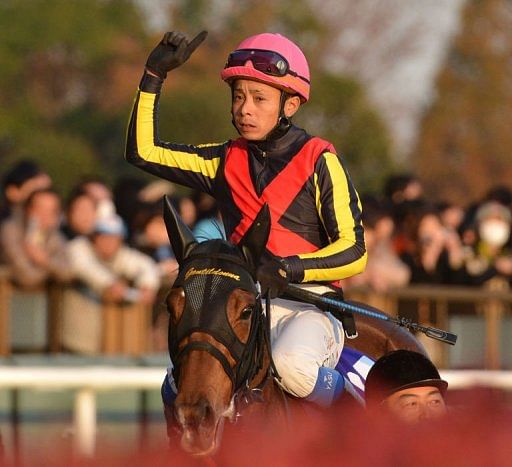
[126, 78, 366, 282]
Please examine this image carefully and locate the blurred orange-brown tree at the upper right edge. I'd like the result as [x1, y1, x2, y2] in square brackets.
[413, 0, 512, 203]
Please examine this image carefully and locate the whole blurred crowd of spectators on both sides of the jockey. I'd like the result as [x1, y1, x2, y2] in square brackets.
[0, 160, 512, 352]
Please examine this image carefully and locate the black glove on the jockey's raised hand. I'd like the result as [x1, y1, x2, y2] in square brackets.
[146, 31, 208, 79]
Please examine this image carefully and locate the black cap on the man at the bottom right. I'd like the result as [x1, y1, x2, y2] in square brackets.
[365, 350, 448, 406]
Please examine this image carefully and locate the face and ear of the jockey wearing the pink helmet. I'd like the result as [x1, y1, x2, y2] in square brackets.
[231, 79, 300, 141]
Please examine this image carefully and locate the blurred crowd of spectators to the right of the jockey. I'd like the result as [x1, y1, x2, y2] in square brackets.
[344, 174, 512, 292]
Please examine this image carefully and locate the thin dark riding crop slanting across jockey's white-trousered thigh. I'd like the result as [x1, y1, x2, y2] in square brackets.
[285, 285, 457, 345]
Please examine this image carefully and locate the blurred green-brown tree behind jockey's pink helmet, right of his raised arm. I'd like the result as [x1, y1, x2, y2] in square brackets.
[155, 0, 393, 191]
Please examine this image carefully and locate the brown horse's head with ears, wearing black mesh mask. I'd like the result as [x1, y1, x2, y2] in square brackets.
[164, 200, 270, 455]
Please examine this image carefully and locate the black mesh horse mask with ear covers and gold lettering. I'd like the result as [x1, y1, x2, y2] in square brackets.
[164, 198, 270, 390]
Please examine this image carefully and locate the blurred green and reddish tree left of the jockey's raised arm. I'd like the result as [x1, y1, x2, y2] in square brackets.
[0, 0, 145, 192]
